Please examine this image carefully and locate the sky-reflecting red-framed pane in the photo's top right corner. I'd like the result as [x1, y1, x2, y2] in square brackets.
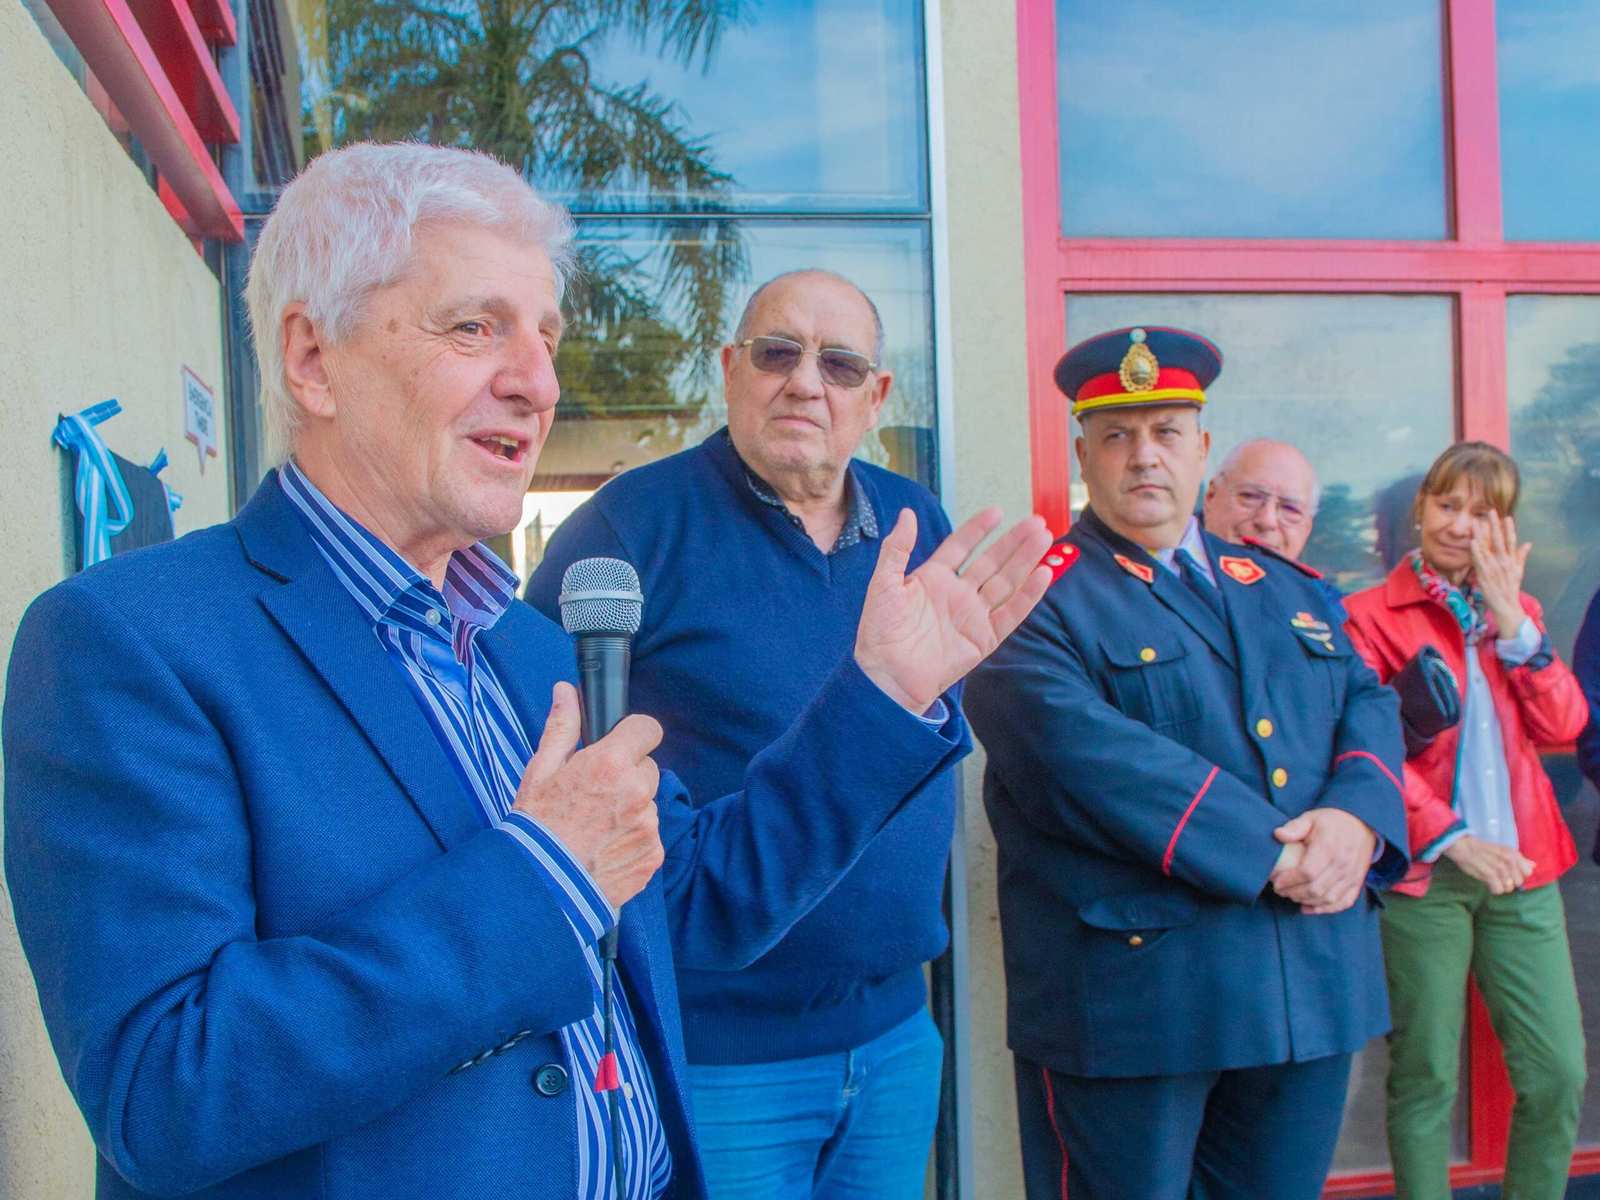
[1494, 0, 1600, 242]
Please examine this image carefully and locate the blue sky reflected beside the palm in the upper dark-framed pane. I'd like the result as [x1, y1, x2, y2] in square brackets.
[562, 0, 926, 211]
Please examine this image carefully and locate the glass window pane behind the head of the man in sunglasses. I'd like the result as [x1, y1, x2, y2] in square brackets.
[512, 219, 936, 585]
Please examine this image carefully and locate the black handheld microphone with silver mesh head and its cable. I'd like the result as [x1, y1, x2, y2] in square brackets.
[560, 558, 645, 1200]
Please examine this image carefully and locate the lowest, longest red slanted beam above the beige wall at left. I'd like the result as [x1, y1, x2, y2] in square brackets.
[50, 0, 245, 242]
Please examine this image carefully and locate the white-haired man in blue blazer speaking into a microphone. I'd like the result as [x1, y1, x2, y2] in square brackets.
[3, 146, 1048, 1200]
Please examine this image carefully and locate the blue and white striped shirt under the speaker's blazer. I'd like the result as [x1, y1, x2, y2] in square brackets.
[278, 461, 672, 1200]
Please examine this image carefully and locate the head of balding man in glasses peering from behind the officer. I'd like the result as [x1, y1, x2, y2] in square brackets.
[1205, 437, 1322, 558]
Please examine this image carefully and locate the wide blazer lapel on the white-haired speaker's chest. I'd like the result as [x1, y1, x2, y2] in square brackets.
[235, 472, 483, 850]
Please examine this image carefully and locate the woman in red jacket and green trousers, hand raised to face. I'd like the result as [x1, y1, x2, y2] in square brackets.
[1349, 442, 1587, 1200]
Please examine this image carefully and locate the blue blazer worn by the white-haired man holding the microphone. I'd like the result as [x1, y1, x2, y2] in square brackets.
[3, 477, 957, 1200]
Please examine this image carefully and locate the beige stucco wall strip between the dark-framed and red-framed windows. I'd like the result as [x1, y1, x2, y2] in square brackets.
[941, 0, 1032, 1200]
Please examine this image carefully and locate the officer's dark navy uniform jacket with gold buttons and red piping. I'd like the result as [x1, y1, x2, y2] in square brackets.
[966, 510, 1406, 1077]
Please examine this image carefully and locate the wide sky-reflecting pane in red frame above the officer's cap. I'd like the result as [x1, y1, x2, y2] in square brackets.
[1056, 0, 1448, 238]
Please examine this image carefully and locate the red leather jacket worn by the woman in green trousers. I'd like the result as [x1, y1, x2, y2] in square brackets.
[1346, 560, 1589, 896]
